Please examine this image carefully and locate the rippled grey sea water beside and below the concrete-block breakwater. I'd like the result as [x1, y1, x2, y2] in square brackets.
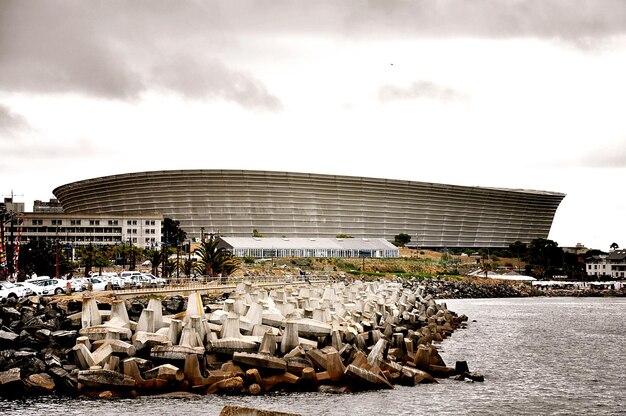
[0, 298, 626, 416]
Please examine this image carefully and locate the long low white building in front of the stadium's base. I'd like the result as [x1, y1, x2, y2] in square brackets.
[218, 237, 400, 258]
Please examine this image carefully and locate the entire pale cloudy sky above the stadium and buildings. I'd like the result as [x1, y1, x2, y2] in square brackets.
[0, 0, 626, 250]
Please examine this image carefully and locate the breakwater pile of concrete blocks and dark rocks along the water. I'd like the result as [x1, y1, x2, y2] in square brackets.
[0, 281, 481, 397]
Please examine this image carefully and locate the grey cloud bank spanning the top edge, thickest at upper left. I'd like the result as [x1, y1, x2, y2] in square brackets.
[0, 0, 626, 105]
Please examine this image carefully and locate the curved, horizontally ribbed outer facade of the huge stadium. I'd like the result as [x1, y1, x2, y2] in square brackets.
[53, 170, 565, 247]
